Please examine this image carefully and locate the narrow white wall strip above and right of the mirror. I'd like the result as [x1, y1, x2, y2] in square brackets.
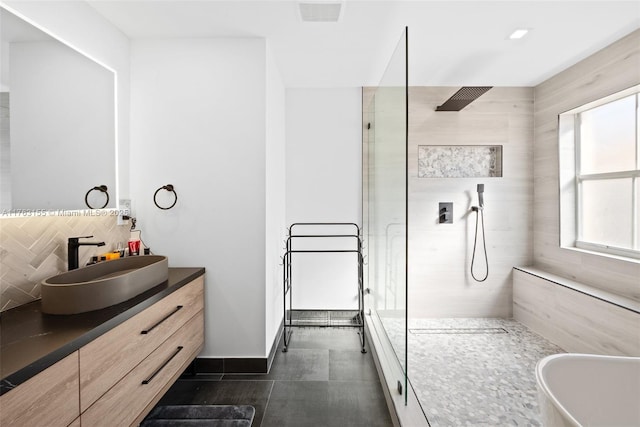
[3, 1, 130, 201]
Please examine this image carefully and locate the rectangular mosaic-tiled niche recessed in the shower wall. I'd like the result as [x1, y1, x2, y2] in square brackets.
[418, 145, 502, 178]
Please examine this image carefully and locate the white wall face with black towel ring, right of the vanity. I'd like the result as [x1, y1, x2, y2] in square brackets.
[131, 38, 282, 357]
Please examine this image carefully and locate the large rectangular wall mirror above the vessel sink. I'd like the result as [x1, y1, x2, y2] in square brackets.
[0, 7, 117, 215]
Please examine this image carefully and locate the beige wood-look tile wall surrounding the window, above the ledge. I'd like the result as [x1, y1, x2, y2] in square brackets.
[533, 30, 640, 301]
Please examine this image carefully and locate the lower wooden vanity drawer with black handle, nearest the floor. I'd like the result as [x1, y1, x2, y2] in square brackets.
[81, 311, 204, 427]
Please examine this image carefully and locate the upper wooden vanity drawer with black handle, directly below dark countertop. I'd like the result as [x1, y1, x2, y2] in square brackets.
[80, 277, 204, 412]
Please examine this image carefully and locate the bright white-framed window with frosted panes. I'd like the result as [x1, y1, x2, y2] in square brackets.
[559, 87, 640, 259]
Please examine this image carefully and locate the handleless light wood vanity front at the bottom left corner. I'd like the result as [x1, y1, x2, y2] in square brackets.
[0, 351, 80, 427]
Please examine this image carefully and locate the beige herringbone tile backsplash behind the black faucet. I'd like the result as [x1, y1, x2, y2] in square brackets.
[0, 211, 130, 311]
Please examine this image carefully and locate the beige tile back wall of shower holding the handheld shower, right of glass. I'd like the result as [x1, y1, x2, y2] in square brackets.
[409, 87, 533, 317]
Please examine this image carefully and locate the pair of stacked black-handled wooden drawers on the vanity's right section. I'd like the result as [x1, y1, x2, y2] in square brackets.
[80, 276, 204, 427]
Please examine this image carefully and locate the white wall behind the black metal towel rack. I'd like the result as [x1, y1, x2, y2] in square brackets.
[286, 88, 362, 309]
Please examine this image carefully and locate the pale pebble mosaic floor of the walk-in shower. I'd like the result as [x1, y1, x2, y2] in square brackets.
[384, 319, 564, 427]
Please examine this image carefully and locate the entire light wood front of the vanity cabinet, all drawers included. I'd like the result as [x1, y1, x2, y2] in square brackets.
[0, 276, 204, 427]
